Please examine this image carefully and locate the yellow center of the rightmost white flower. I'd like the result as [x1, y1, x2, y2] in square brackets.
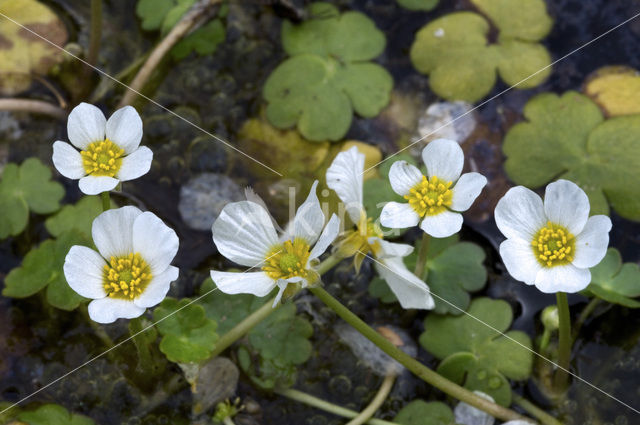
[531, 221, 576, 267]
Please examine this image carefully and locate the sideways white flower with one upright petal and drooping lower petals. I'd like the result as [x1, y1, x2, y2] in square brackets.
[327, 146, 434, 309]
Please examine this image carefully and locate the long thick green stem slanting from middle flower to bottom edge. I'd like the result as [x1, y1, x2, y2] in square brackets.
[310, 288, 536, 424]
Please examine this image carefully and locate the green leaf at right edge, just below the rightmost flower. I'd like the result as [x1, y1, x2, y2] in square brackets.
[587, 248, 640, 308]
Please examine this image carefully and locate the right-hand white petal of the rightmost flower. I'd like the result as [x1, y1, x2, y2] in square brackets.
[572, 215, 611, 269]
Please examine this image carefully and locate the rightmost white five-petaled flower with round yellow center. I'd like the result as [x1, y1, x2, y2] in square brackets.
[495, 180, 611, 293]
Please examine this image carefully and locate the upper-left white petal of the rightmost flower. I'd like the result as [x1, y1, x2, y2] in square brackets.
[495, 186, 547, 243]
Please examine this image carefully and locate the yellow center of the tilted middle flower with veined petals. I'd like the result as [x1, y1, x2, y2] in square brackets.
[262, 238, 311, 280]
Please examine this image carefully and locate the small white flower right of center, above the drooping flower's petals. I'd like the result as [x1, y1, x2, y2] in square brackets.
[380, 139, 487, 238]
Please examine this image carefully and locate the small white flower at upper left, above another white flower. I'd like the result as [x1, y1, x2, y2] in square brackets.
[53, 103, 153, 195]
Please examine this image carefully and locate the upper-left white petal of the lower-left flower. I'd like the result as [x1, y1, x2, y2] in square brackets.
[91, 206, 142, 259]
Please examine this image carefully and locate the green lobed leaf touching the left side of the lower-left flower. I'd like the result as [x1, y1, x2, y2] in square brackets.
[2, 230, 91, 310]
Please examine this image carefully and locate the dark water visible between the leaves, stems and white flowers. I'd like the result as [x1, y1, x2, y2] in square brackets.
[0, 0, 640, 425]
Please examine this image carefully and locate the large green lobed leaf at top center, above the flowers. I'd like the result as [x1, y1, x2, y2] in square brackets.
[263, 3, 393, 141]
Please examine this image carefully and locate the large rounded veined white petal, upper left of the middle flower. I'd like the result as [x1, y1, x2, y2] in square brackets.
[212, 201, 278, 267]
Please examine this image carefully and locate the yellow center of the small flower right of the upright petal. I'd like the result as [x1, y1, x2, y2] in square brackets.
[404, 176, 453, 217]
